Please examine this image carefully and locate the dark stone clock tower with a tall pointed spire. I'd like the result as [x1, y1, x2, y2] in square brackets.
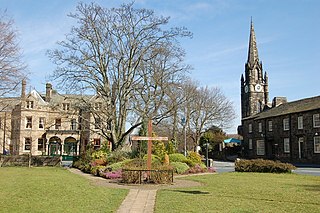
[241, 20, 269, 119]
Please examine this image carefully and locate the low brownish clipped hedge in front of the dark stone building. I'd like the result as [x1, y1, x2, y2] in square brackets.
[235, 159, 296, 173]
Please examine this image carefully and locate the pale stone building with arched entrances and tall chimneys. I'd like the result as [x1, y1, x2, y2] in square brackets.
[0, 81, 106, 156]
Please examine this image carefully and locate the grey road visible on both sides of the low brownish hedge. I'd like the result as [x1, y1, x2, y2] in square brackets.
[213, 161, 320, 176]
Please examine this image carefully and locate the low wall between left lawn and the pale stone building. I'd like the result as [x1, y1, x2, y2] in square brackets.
[0, 155, 61, 167]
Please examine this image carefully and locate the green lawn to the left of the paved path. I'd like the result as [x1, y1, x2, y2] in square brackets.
[0, 167, 128, 213]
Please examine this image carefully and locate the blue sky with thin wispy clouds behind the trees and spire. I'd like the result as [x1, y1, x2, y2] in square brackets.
[0, 0, 320, 133]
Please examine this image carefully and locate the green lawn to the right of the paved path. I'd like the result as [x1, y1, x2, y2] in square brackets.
[155, 172, 320, 213]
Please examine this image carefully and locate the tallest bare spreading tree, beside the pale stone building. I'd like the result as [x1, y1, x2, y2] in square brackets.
[48, 3, 191, 148]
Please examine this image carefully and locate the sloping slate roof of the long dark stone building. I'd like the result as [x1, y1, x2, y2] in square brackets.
[243, 96, 320, 120]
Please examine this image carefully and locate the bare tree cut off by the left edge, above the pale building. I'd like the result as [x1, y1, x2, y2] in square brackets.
[0, 11, 26, 97]
